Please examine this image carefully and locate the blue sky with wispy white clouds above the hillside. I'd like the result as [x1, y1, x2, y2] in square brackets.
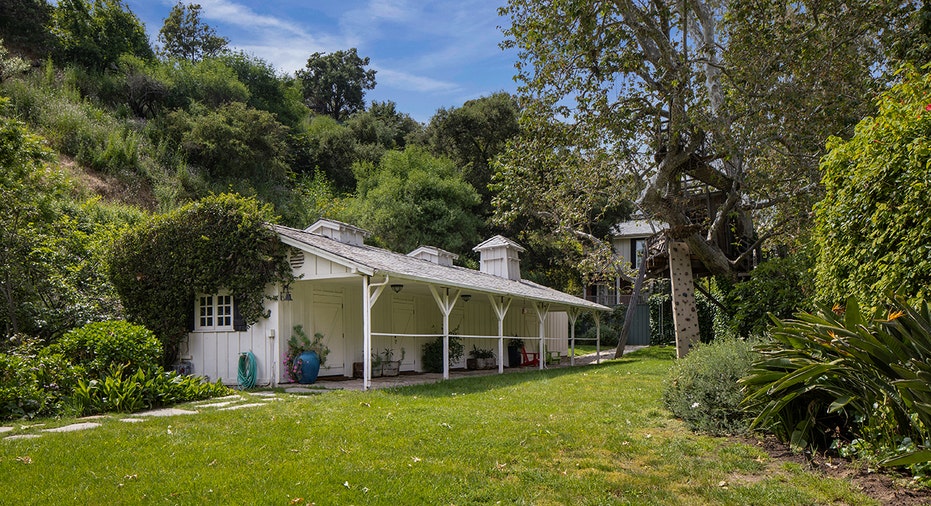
[126, 0, 516, 122]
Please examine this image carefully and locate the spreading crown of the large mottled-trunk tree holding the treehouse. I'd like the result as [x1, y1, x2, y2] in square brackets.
[497, 0, 898, 277]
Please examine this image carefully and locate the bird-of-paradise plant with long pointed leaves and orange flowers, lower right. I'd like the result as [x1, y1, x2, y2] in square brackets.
[743, 296, 931, 464]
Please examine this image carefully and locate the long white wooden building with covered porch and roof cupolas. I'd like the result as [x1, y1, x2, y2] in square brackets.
[182, 220, 610, 388]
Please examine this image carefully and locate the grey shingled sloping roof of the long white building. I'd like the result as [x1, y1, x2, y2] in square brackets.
[271, 225, 611, 311]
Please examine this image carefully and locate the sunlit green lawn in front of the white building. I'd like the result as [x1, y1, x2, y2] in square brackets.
[0, 348, 872, 505]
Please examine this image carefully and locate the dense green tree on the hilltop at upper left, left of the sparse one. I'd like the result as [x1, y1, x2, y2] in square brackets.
[52, 0, 154, 70]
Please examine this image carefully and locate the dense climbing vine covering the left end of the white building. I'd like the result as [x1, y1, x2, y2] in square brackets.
[110, 194, 291, 365]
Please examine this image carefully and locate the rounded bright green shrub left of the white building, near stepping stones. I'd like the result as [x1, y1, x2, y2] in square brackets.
[58, 320, 162, 378]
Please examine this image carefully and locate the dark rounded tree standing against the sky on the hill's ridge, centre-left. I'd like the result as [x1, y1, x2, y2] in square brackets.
[297, 48, 375, 121]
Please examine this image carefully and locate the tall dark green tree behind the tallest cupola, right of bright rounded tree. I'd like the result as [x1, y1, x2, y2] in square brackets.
[426, 92, 518, 214]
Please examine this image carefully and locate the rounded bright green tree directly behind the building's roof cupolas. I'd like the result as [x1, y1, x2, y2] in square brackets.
[347, 146, 481, 252]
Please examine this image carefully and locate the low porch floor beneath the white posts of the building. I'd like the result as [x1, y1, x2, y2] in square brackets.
[283, 346, 643, 394]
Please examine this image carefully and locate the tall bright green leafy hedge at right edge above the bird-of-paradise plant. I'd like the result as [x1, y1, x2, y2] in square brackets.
[814, 67, 931, 306]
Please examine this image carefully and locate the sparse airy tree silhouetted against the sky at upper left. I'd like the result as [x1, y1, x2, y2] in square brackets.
[158, 2, 229, 63]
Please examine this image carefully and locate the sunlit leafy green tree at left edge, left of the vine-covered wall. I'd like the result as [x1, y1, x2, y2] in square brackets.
[0, 99, 138, 339]
